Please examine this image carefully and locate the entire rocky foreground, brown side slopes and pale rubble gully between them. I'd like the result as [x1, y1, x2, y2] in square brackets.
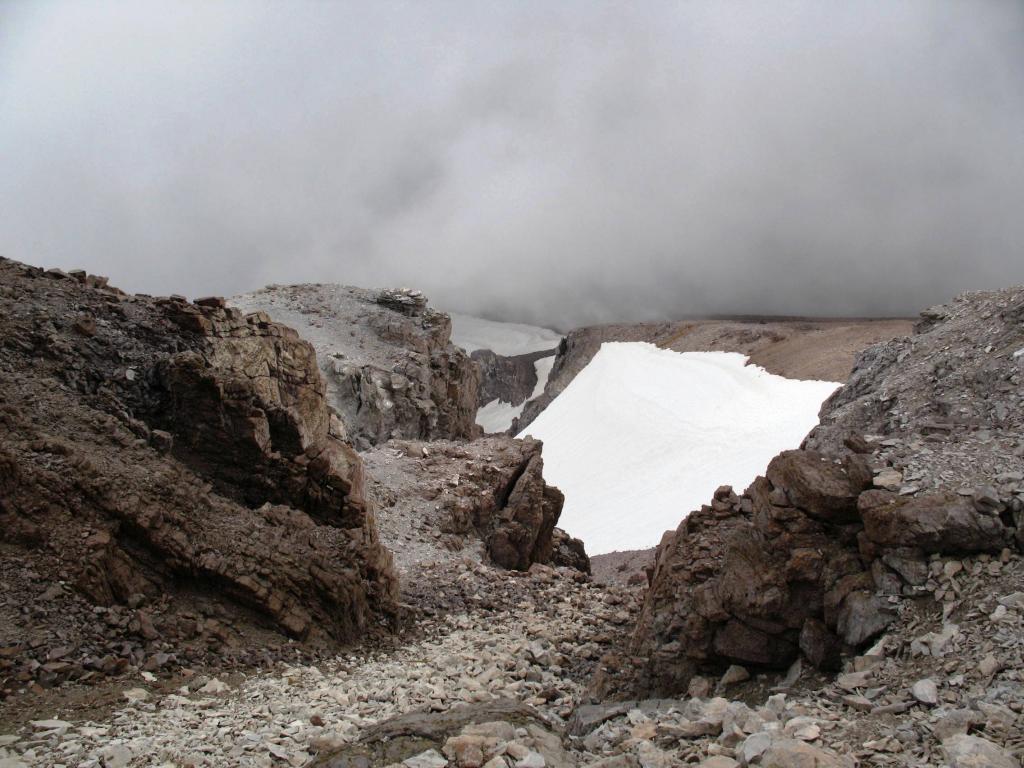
[0, 262, 1024, 768]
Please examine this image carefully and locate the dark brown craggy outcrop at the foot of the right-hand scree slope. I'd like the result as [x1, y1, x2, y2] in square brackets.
[636, 451, 881, 691]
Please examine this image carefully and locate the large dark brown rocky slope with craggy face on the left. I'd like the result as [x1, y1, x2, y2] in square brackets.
[0, 260, 396, 696]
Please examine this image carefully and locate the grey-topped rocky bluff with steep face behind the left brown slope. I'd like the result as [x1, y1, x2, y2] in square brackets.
[230, 285, 479, 450]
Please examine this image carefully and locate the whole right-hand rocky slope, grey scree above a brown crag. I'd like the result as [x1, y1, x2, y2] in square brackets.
[634, 289, 1024, 691]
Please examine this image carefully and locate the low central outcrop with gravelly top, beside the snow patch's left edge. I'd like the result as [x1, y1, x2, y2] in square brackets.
[365, 436, 590, 590]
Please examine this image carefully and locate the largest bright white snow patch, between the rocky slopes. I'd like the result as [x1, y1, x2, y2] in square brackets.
[519, 342, 840, 555]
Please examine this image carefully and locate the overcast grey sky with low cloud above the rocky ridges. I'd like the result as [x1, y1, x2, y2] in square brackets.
[0, 0, 1024, 329]
